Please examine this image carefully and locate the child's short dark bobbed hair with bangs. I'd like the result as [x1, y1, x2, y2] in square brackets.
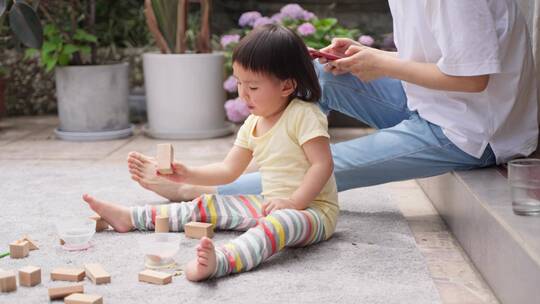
[232, 24, 321, 102]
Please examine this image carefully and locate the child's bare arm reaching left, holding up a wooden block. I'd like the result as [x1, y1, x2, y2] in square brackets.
[158, 146, 253, 186]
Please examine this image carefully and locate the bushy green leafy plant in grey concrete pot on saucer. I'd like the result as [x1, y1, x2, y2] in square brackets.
[26, 0, 133, 141]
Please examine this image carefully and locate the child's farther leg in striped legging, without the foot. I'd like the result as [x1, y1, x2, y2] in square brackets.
[131, 194, 263, 231]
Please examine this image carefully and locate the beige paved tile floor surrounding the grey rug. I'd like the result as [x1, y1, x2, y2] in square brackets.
[0, 117, 498, 304]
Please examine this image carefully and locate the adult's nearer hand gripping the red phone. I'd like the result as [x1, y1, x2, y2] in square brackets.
[331, 45, 388, 82]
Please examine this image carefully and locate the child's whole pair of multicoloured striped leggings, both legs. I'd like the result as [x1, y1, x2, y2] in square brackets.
[131, 194, 325, 277]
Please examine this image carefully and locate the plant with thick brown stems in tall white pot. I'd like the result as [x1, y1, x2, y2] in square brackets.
[143, 0, 232, 139]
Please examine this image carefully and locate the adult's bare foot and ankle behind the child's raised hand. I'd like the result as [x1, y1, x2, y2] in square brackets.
[127, 152, 211, 202]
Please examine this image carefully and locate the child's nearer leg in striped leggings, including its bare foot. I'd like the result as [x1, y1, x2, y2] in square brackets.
[186, 208, 326, 281]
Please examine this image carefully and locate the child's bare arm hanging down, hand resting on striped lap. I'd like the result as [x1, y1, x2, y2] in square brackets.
[263, 136, 334, 214]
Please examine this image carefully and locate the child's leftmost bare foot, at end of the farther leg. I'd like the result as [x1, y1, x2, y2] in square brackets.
[83, 194, 134, 232]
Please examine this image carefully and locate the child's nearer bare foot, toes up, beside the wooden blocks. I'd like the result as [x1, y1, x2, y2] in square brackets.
[186, 237, 216, 281]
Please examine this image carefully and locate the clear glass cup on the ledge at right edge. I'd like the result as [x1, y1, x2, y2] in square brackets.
[508, 158, 540, 215]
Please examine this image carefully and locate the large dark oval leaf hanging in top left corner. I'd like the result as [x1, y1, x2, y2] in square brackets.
[9, 1, 43, 49]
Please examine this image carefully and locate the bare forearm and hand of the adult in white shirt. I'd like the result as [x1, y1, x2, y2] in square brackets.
[330, 45, 489, 93]
